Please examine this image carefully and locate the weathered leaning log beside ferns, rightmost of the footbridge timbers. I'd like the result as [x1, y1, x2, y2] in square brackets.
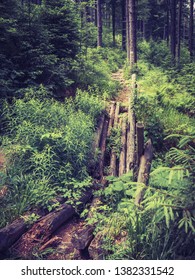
[135, 140, 153, 206]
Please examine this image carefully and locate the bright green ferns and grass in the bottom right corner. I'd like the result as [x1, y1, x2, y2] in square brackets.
[93, 166, 195, 259]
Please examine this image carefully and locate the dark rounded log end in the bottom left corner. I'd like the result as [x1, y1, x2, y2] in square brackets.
[0, 218, 28, 252]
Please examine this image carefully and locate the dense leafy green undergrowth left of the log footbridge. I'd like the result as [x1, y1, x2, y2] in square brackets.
[1, 87, 104, 224]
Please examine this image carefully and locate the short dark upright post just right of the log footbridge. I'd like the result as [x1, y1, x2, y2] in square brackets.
[136, 122, 144, 167]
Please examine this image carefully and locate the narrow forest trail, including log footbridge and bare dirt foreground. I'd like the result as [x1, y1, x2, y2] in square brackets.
[1, 69, 136, 260]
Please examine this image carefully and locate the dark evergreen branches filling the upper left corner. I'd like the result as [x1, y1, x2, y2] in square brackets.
[0, 0, 79, 97]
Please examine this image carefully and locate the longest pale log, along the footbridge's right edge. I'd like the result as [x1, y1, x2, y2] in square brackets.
[126, 75, 136, 172]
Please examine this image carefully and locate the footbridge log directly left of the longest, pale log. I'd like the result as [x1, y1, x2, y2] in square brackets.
[119, 118, 126, 176]
